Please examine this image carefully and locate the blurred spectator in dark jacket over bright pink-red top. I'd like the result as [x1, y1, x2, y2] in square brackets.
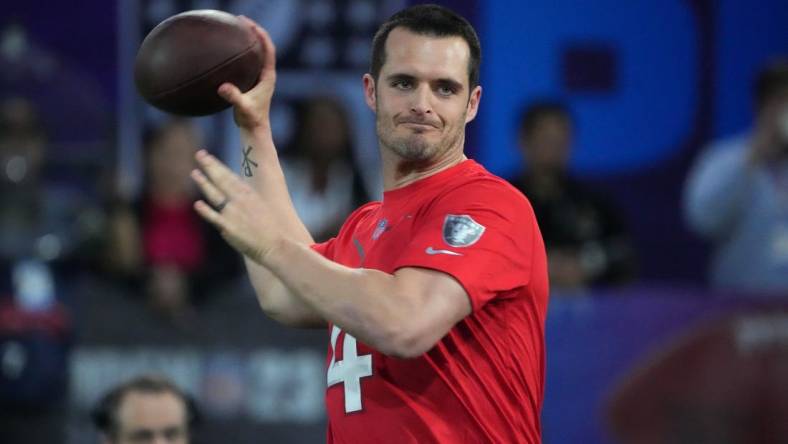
[105, 120, 240, 322]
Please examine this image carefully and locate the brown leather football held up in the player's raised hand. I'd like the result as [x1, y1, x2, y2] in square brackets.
[134, 9, 264, 116]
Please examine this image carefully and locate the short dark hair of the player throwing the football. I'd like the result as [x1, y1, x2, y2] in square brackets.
[370, 5, 482, 88]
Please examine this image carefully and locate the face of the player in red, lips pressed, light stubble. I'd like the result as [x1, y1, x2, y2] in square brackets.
[364, 28, 481, 166]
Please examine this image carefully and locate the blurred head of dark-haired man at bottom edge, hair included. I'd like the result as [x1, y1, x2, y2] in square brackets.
[91, 376, 199, 444]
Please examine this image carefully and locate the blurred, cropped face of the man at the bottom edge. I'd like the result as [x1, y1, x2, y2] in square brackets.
[113, 392, 189, 444]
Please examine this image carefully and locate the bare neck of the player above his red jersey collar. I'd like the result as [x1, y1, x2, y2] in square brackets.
[381, 149, 467, 191]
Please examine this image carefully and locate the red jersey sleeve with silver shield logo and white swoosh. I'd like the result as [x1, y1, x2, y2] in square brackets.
[394, 181, 544, 311]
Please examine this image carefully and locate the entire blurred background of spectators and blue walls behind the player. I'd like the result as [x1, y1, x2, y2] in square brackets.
[0, 0, 788, 443]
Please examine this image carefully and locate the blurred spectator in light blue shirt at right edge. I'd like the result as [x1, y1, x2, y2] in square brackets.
[684, 58, 788, 296]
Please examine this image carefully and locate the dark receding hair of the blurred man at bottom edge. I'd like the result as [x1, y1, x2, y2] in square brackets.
[90, 375, 200, 437]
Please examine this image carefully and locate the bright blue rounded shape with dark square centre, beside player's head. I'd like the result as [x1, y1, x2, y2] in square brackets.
[481, 0, 698, 175]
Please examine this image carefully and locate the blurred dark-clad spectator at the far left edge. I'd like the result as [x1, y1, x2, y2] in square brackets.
[0, 97, 103, 261]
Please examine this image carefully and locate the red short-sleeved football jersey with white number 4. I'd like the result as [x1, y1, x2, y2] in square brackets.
[313, 160, 548, 444]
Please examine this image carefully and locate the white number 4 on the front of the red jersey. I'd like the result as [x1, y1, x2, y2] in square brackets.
[326, 325, 372, 413]
